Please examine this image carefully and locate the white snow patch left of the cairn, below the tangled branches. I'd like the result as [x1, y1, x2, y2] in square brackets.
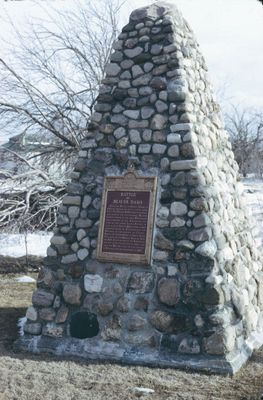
[0, 231, 53, 257]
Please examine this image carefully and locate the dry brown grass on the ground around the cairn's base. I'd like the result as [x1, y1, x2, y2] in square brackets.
[0, 275, 263, 400]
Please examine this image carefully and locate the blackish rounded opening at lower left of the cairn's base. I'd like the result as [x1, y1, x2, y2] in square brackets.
[70, 311, 100, 339]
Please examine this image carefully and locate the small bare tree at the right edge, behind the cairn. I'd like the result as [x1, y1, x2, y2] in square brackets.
[225, 107, 263, 176]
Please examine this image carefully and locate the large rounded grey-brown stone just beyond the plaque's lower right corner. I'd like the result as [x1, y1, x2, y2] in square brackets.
[157, 278, 180, 306]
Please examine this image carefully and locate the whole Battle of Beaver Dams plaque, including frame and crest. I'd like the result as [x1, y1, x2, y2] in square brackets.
[97, 171, 157, 264]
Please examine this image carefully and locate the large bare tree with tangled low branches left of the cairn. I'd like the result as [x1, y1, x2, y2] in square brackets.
[0, 0, 125, 228]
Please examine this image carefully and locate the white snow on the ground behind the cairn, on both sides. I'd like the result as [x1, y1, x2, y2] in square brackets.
[0, 178, 263, 257]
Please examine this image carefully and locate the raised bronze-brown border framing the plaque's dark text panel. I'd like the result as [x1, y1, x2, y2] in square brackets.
[97, 170, 157, 265]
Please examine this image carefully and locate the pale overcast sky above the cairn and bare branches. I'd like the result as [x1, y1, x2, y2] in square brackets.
[0, 0, 263, 111]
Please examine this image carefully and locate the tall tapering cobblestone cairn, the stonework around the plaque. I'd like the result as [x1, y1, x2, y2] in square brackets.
[17, 2, 263, 373]
